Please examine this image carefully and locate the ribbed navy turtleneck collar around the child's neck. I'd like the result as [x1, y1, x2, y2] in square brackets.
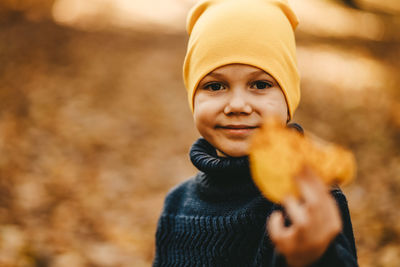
[190, 123, 303, 197]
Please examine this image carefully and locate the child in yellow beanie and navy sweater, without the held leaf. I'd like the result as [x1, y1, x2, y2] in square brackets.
[153, 0, 358, 267]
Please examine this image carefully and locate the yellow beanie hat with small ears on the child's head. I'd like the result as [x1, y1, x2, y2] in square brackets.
[183, 0, 300, 118]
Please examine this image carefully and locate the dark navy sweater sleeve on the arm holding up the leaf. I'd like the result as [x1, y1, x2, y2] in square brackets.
[272, 188, 358, 267]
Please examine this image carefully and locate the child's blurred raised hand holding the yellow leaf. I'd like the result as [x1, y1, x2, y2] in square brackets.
[268, 168, 342, 267]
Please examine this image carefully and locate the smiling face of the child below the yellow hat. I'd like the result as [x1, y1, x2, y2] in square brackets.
[193, 64, 288, 157]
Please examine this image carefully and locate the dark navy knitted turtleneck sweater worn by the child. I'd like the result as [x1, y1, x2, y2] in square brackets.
[153, 129, 358, 267]
